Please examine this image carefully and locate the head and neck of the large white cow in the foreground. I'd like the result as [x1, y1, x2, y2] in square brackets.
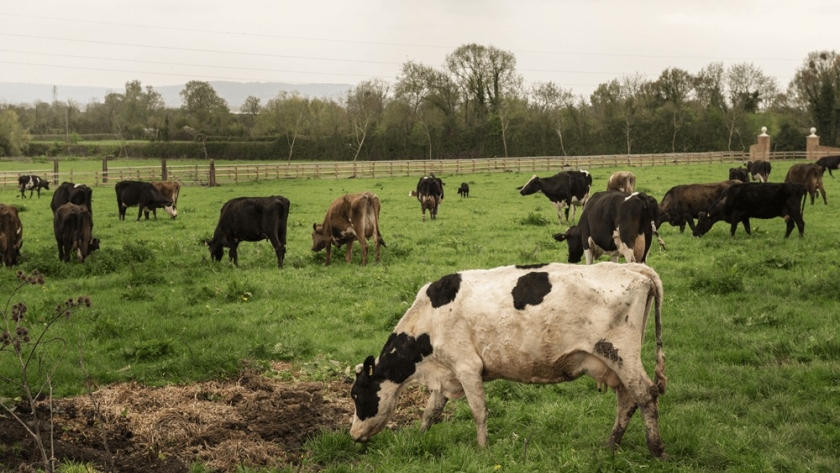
[350, 332, 433, 442]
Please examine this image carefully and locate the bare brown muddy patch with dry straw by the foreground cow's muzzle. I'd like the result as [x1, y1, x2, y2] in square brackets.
[0, 367, 434, 473]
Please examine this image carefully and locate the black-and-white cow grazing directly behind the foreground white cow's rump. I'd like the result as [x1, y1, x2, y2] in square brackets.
[554, 191, 664, 264]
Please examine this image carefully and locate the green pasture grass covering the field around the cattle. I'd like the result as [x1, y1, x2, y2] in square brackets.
[0, 161, 840, 472]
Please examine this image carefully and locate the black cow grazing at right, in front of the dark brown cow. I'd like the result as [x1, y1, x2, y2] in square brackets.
[694, 182, 807, 238]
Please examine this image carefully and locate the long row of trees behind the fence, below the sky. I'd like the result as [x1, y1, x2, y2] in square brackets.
[0, 44, 840, 160]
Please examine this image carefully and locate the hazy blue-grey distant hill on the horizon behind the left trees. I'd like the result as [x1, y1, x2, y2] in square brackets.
[0, 81, 354, 111]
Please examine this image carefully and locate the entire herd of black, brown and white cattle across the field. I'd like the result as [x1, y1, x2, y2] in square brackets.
[0, 156, 840, 457]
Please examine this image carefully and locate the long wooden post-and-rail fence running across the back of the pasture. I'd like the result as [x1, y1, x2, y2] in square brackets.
[0, 151, 828, 189]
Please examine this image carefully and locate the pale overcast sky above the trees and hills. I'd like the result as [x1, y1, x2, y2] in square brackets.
[0, 0, 840, 96]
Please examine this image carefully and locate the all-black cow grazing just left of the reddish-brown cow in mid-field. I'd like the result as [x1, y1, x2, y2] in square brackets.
[204, 195, 289, 268]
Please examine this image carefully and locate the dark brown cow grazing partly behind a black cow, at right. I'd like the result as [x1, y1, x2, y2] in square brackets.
[656, 180, 741, 233]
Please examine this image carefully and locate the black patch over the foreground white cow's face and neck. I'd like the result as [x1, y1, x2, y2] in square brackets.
[350, 333, 433, 420]
